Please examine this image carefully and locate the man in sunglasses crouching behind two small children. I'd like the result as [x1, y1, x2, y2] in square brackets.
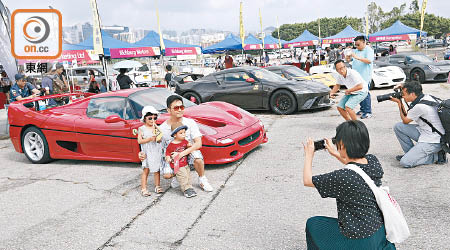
[139, 95, 213, 192]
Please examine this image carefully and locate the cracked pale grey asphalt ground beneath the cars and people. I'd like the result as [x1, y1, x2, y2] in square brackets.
[0, 83, 450, 250]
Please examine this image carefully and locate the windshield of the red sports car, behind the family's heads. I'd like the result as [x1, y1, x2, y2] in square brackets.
[129, 88, 197, 117]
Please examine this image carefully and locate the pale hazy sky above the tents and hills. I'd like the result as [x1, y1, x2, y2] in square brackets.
[1, 0, 450, 32]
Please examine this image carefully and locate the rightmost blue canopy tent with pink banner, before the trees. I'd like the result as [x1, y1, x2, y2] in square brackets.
[369, 20, 427, 42]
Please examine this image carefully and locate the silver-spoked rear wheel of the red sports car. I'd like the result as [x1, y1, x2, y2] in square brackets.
[22, 127, 51, 163]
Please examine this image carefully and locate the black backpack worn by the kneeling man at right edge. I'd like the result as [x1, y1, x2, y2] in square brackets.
[418, 96, 450, 154]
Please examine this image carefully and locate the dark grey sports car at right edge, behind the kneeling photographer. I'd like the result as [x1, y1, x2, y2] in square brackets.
[374, 52, 450, 83]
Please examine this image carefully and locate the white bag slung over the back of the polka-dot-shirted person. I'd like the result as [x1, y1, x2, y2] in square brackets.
[345, 164, 410, 243]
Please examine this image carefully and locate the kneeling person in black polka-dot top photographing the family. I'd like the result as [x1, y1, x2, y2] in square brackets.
[303, 121, 395, 250]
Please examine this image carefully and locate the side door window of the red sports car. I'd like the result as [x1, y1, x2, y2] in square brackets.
[87, 97, 133, 120]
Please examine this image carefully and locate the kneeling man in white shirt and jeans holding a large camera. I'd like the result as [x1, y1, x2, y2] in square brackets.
[391, 81, 446, 168]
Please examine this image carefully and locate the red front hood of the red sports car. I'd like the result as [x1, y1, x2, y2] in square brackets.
[158, 102, 259, 139]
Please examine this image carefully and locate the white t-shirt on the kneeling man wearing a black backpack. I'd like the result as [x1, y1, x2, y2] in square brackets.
[407, 95, 445, 143]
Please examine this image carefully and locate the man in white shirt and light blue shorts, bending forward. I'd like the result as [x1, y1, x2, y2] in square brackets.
[330, 60, 369, 121]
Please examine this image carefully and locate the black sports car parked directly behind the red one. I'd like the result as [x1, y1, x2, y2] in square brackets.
[175, 67, 331, 114]
